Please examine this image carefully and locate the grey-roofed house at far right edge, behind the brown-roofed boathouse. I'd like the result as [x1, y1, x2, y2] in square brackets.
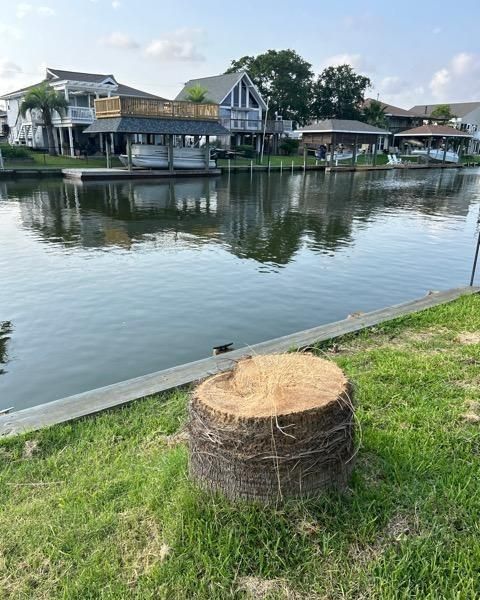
[410, 102, 480, 154]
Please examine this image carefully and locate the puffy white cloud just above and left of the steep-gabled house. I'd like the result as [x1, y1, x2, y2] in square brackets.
[145, 29, 205, 62]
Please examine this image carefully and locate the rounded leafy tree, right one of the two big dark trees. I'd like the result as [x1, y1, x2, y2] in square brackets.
[313, 65, 372, 119]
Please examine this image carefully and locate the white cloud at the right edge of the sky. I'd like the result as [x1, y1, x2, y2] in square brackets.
[429, 52, 480, 102]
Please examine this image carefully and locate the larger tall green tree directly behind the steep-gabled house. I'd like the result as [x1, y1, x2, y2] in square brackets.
[226, 50, 313, 125]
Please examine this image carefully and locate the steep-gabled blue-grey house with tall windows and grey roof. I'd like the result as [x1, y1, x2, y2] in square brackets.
[176, 71, 293, 151]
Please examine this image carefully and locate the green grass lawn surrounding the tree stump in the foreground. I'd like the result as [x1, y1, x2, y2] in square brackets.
[0, 295, 480, 600]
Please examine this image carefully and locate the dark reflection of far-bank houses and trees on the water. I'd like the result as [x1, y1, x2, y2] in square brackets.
[13, 170, 474, 265]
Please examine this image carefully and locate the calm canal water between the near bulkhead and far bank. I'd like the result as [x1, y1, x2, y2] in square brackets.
[0, 169, 480, 409]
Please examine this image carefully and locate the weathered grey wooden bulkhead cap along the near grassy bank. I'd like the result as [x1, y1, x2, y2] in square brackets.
[0, 287, 480, 437]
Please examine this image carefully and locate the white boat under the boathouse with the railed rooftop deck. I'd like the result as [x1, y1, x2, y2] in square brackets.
[120, 144, 216, 169]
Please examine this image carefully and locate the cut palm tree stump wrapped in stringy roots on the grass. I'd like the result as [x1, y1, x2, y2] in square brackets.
[189, 353, 354, 503]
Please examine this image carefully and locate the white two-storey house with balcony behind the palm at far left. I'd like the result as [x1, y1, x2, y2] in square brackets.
[1, 68, 163, 156]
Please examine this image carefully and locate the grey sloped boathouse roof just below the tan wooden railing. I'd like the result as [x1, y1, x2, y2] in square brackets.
[84, 117, 230, 135]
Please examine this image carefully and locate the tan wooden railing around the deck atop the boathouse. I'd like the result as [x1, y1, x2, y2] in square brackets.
[95, 96, 219, 121]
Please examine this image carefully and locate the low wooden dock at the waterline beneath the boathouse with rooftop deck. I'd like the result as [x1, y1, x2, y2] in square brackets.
[62, 168, 222, 181]
